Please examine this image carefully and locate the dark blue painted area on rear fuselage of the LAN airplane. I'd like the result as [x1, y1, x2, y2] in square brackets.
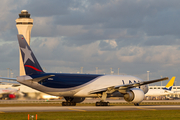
[30, 73, 103, 88]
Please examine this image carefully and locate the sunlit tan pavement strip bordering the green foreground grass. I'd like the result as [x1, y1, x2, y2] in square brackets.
[0, 105, 180, 113]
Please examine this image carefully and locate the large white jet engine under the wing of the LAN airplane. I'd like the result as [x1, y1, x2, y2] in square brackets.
[124, 88, 144, 103]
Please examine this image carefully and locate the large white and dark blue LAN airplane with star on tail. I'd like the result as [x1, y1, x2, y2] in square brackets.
[0, 35, 168, 106]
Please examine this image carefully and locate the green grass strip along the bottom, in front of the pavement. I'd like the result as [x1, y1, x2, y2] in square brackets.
[0, 110, 180, 120]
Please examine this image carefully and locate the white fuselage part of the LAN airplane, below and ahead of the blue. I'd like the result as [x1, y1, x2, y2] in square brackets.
[17, 75, 148, 97]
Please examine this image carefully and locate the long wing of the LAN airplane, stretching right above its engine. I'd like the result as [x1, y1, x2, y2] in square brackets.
[90, 77, 169, 94]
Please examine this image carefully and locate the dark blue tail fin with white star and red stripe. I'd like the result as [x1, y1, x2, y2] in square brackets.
[17, 34, 44, 75]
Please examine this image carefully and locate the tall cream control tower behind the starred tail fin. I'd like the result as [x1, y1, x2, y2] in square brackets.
[16, 10, 33, 76]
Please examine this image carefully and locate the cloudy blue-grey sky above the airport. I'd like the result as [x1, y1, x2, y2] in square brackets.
[0, 0, 180, 85]
